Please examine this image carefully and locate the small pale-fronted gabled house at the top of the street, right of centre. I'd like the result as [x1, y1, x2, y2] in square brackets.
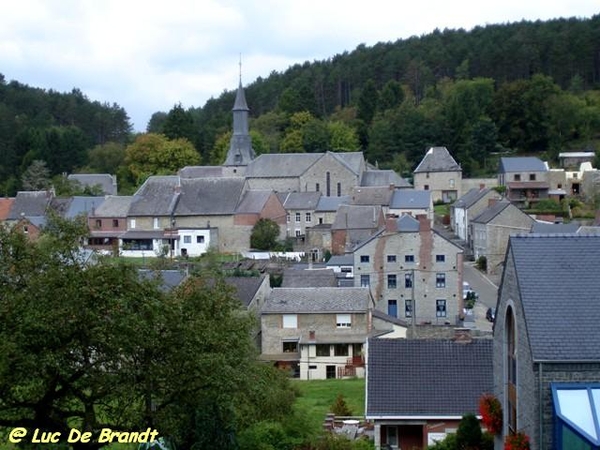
[450, 186, 502, 243]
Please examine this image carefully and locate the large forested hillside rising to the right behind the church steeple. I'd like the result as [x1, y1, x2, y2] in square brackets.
[158, 16, 600, 174]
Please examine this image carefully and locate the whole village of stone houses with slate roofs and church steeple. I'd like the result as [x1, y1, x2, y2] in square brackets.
[0, 83, 600, 449]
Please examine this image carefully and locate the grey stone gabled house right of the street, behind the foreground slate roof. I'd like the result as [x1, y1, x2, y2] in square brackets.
[470, 199, 535, 275]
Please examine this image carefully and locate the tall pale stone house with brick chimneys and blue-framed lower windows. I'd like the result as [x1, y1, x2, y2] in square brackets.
[354, 215, 463, 325]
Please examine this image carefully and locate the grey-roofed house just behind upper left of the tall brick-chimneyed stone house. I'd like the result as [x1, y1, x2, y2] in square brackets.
[331, 205, 385, 255]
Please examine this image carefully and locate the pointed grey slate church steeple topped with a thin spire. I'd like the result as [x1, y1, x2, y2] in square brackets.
[224, 59, 256, 166]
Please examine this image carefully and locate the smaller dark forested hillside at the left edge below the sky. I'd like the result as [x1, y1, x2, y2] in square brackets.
[0, 74, 131, 195]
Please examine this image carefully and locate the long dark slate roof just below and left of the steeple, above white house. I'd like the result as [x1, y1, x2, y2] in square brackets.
[175, 177, 245, 216]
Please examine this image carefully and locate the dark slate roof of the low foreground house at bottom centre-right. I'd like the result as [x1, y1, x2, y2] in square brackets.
[366, 338, 493, 417]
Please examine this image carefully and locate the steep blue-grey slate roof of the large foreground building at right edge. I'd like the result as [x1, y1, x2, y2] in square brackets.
[503, 234, 600, 361]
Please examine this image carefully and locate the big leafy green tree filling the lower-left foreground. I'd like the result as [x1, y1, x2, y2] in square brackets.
[0, 216, 294, 449]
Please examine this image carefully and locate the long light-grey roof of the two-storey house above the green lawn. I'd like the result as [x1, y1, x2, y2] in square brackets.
[262, 287, 371, 314]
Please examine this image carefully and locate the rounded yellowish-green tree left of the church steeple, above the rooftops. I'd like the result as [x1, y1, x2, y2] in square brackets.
[124, 133, 200, 184]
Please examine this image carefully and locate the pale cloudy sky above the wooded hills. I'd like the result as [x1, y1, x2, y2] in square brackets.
[0, 0, 600, 131]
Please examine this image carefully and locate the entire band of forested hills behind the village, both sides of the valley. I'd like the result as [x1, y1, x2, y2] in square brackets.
[0, 15, 600, 195]
